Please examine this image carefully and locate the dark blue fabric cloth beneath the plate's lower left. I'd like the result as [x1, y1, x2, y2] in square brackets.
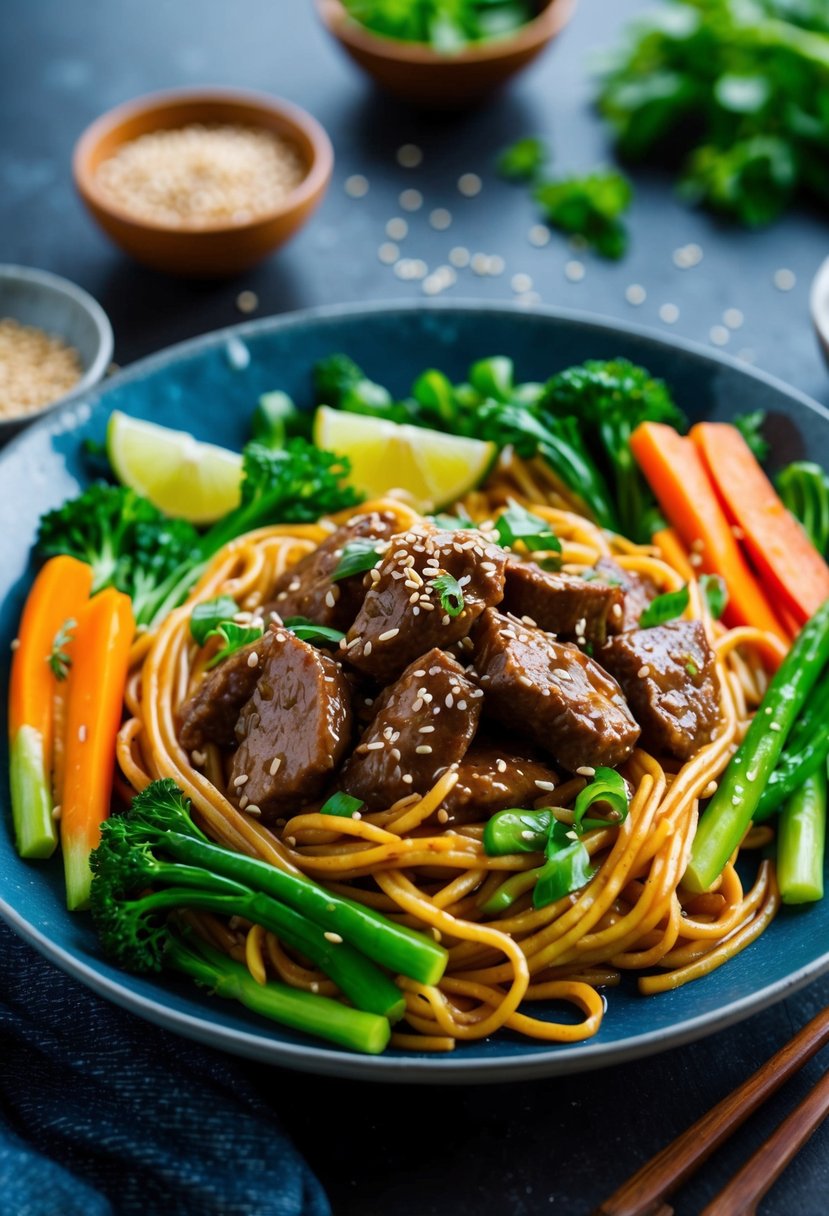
[0, 924, 331, 1216]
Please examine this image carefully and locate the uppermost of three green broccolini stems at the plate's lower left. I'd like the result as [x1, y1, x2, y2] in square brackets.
[160, 832, 449, 985]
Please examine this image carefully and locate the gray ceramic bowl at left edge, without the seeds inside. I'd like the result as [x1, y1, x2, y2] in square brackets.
[0, 265, 113, 445]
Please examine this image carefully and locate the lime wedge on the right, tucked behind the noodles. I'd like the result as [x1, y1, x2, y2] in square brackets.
[314, 405, 497, 512]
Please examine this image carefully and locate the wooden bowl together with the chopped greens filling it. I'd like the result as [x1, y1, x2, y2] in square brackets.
[316, 0, 575, 108]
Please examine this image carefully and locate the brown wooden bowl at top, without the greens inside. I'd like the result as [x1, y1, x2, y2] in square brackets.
[316, 0, 575, 109]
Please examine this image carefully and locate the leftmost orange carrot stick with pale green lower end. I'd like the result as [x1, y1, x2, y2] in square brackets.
[9, 556, 92, 857]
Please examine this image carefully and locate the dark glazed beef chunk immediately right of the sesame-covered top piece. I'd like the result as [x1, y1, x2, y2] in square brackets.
[503, 558, 625, 646]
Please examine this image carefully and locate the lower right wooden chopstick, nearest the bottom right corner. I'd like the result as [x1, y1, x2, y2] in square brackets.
[701, 1073, 829, 1216]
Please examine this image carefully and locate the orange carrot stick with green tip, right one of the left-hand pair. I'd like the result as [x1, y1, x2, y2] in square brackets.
[61, 587, 135, 912]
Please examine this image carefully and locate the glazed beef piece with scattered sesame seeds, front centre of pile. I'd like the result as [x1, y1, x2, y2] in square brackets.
[340, 649, 483, 811]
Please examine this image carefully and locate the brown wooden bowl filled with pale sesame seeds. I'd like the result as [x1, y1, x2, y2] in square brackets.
[73, 89, 334, 278]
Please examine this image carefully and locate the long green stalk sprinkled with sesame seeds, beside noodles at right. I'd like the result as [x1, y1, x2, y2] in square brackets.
[682, 599, 829, 893]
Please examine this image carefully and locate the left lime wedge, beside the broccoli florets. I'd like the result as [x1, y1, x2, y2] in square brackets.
[107, 410, 242, 524]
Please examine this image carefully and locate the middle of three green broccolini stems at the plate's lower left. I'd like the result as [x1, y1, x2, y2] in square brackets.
[130, 880, 405, 1021]
